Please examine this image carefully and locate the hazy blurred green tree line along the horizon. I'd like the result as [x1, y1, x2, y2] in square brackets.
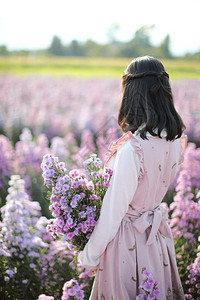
[0, 25, 200, 59]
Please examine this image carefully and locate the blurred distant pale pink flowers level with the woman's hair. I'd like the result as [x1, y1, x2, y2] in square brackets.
[0, 75, 200, 141]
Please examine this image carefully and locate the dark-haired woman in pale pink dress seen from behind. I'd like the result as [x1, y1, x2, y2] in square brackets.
[79, 56, 187, 300]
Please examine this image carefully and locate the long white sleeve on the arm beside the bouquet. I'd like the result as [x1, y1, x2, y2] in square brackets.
[79, 132, 142, 269]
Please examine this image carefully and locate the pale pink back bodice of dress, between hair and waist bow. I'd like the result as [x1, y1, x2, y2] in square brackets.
[130, 135, 184, 211]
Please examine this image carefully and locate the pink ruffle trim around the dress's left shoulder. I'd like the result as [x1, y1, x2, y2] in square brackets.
[105, 131, 144, 182]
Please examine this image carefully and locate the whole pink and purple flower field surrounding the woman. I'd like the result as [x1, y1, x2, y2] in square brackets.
[0, 75, 200, 300]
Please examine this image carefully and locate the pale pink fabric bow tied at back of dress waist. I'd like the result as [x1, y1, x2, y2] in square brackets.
[124, 205, 172, 245]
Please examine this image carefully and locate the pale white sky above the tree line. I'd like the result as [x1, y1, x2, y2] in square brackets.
[0, 0, 200, 55]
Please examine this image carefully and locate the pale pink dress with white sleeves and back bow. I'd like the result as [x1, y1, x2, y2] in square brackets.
[79, 127, 187, 300]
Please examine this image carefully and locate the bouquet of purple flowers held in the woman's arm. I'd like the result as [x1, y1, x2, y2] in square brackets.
[41, 154, 113, 251]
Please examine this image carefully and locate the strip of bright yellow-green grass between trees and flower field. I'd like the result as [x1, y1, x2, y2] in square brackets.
[0, 57, 200, 80]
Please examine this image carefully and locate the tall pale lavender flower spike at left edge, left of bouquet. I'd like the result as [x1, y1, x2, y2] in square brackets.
[0, 176, 46, 257]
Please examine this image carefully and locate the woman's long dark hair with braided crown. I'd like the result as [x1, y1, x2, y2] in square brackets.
[118, 56, 186, 141]
